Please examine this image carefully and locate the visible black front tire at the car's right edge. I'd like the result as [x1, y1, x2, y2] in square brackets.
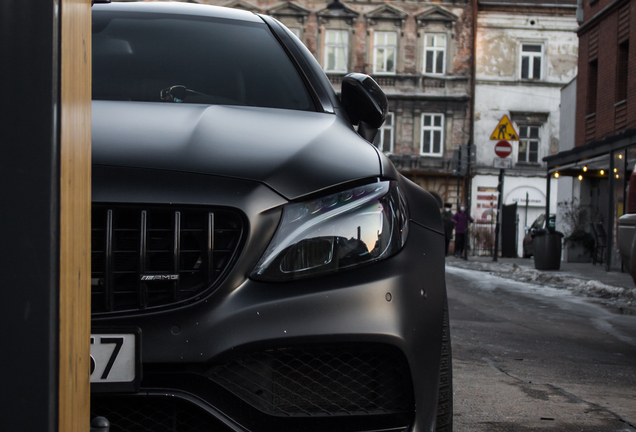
[435, 299, 453, 432]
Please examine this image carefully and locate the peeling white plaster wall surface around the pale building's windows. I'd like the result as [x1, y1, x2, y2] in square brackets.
[471, 10, 578, 256]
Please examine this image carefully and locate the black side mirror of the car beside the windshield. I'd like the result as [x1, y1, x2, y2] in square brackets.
[340, 73, 389, 142]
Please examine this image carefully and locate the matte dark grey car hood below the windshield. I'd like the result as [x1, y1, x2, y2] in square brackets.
[92, 101, 380, 200]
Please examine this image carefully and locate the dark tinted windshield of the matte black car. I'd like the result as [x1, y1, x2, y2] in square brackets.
[93, 11, 316, 111]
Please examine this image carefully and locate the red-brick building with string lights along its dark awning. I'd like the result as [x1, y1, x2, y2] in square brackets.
[546, 0, 636, 269]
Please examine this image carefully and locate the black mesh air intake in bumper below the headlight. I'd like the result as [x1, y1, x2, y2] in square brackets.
[211, 345, 413, 417]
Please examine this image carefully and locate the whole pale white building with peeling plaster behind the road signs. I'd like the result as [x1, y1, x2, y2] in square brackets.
[471, 0, 578, 256]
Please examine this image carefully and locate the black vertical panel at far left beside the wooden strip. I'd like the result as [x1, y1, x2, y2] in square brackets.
[0, 0, 59, 432]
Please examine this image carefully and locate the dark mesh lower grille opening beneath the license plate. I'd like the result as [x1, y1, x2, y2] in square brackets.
[91, 396, 231, 432]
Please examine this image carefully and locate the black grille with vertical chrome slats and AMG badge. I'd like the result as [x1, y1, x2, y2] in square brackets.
[91, 204, 243, 313]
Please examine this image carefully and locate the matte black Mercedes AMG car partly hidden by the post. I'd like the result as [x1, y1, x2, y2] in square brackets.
[91, 2, 452, 432]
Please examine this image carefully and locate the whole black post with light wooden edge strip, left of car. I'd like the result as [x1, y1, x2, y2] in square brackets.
[0, 0, 91, 432]
